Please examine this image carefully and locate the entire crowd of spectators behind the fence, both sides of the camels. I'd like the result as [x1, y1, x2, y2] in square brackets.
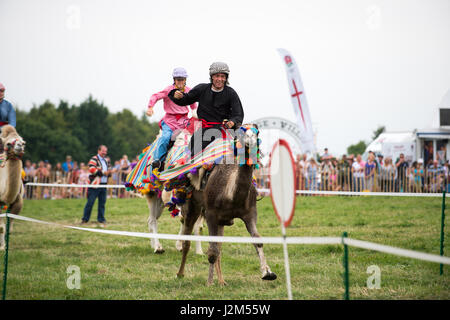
[24, 149, 450, 199]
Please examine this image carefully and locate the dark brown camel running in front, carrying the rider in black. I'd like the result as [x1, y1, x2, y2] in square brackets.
[177, 125, 277, 285]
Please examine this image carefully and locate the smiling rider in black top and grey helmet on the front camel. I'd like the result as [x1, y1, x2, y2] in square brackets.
[168, 62, 244, 155]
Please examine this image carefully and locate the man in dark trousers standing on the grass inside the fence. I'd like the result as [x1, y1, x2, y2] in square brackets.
[81, 145, 111, 228]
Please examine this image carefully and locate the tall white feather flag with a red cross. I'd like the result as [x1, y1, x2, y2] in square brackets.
[278, 49, 316, 153]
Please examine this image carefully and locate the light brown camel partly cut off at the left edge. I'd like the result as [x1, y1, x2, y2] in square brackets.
[0, 125, 25, 250]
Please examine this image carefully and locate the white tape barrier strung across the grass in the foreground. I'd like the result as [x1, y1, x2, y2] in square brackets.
[0, 213, 450, 264]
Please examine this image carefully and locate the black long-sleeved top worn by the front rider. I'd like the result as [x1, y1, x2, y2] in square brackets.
[169, 83, 244, 126]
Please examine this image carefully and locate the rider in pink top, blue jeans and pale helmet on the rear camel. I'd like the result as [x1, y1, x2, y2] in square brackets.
[146, 68, 197, 169]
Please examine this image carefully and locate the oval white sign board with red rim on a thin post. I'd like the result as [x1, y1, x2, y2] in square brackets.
[269, 139, 295, 227]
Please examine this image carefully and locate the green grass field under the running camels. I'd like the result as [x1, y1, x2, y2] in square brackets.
[0, 196, 450, 300]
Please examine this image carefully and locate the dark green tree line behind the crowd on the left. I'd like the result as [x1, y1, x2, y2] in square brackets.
[16, 96, 159, 163]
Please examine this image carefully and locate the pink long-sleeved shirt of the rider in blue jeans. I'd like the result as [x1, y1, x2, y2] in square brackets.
[148, 85, 197, 131]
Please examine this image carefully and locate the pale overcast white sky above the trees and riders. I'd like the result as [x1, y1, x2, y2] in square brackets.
[0, 0, 450, 155]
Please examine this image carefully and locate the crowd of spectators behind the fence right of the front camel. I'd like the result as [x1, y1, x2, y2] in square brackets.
[257, 149, 450, 193]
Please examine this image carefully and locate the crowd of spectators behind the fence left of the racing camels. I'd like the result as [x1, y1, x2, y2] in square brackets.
[23, 155, 138, 199]
